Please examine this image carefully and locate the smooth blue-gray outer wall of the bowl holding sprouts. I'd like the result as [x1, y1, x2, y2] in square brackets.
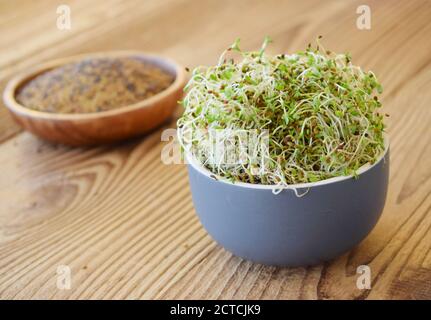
[188, 149, 389, 266]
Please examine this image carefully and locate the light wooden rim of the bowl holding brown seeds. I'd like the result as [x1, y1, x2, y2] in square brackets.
[3, 50, 186, 121]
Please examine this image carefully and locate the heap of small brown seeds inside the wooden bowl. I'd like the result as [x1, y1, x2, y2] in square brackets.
[16, 57, 174, 113]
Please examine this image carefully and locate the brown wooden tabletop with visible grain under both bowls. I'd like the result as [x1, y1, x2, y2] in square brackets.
[0, 0, 431, 299]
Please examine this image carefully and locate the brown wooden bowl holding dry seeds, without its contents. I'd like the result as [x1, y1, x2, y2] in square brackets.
[3, 51, 186, 146]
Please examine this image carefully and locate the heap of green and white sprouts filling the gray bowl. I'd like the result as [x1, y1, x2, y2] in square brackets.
[178, 39, 385, 186]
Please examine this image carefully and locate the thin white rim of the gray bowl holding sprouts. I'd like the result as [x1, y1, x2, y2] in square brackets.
[184, 134, 389, 190]
